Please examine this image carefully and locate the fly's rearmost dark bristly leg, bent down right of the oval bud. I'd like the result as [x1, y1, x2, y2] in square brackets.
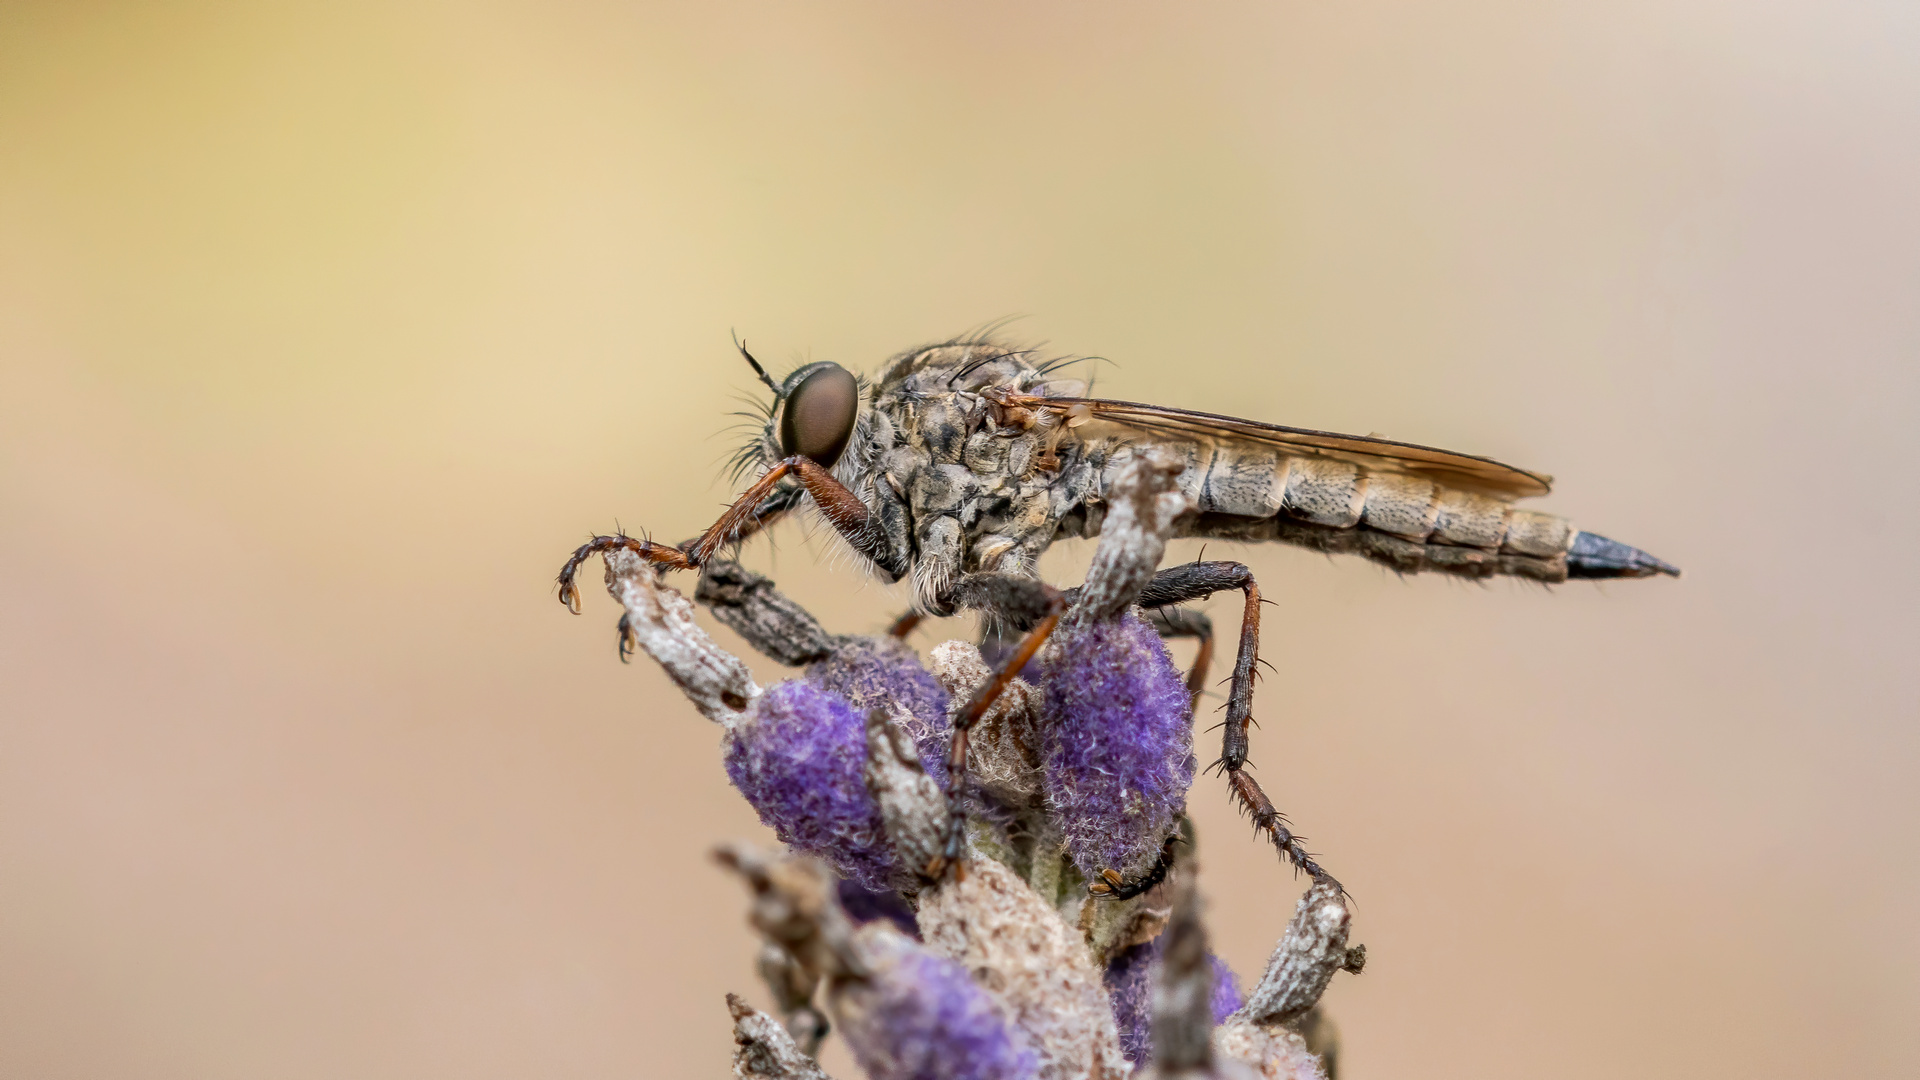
[1140, 563, 1338, 884]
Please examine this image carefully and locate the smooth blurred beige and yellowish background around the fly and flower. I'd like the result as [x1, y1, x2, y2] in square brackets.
[0, 0, 1920, 1080]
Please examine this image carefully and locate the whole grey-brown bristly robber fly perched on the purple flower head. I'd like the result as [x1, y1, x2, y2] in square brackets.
[561, 336, 1680, 892]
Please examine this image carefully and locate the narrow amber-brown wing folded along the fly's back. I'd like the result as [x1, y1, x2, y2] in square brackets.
[1020, 398, 1553, 500]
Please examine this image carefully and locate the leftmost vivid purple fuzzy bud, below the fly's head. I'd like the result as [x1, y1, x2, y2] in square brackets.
[724, 678, 893, 890]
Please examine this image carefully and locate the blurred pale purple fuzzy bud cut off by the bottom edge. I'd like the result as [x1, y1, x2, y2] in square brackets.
[839, 934, 1037, 1080]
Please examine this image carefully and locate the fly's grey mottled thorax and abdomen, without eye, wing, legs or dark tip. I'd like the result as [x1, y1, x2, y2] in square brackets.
[760, 342, 1580, 613]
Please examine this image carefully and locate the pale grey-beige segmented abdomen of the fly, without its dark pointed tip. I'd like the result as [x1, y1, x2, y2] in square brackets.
[1090, 444, 1574, 582]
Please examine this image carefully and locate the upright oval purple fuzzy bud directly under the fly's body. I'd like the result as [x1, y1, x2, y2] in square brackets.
[1043, 611, 1194, 876]
